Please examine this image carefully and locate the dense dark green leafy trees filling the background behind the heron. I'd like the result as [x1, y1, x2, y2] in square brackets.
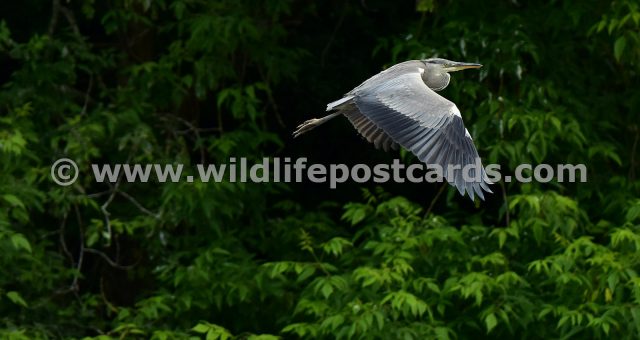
[0, 0, 640, 339]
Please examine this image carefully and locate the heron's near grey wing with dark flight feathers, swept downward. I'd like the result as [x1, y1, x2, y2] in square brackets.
[354, 68, 491, 199]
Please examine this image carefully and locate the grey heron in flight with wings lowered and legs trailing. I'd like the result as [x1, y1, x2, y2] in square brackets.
[293, 58, 492, 200]
